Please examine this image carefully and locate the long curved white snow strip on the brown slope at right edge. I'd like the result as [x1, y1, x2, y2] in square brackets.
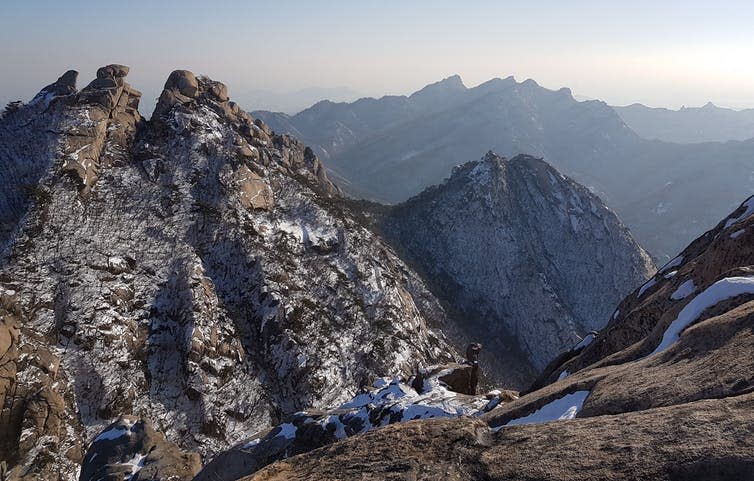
[649, 277, 754, 356]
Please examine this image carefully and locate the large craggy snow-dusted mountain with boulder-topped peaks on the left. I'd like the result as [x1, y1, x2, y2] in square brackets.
[0, 65, 458, 481]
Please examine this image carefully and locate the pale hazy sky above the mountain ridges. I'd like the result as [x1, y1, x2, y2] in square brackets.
[0, 0, 754, 113]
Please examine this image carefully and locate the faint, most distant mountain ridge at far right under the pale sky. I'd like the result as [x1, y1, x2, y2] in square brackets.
[613, 102, 754, 144]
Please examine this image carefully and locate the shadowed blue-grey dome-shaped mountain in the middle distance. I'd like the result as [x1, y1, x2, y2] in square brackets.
[380, 152, 655, 376]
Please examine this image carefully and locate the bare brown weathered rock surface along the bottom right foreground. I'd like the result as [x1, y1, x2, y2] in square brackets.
[240, 394, 754, 481]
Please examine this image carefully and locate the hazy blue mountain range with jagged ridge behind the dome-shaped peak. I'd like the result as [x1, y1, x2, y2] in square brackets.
[254, 77, 754, 260]
